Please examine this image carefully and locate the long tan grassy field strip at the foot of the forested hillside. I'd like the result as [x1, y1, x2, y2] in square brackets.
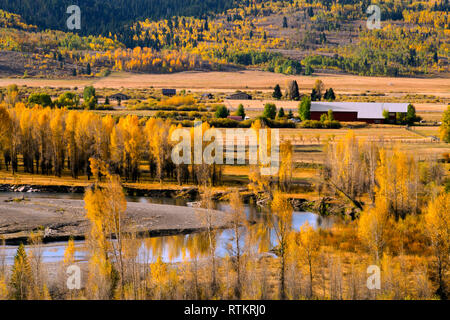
[0, 70, 450, 97]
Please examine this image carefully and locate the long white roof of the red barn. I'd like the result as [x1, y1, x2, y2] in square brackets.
[311, 102, 408, 119]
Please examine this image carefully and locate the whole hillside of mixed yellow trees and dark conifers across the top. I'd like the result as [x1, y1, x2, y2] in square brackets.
[0, 0, 450, 76]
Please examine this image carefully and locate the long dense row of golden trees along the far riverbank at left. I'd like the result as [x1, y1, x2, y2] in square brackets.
[0, 100, 292, 188]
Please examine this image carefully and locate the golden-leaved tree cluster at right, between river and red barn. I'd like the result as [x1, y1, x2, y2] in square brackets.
[322, 131, 445, 214]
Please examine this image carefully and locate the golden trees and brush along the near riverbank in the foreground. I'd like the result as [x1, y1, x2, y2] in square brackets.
[0, 168, 450, 299]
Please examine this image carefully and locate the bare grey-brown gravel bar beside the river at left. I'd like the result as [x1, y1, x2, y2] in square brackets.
[0, 196, 226, 244]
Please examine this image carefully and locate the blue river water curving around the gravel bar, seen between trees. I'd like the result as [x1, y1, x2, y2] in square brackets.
[0, 192, 335, 265]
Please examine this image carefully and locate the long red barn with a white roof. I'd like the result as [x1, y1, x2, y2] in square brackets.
[311, 102, 408, 123]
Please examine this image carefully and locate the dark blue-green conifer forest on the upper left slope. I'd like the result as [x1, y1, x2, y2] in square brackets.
[0, 0, 241, 34]
